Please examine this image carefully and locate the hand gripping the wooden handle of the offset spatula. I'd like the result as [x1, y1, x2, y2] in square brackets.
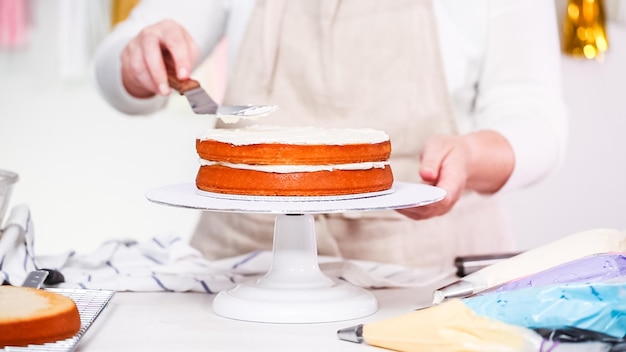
[121, 20, 199, 98]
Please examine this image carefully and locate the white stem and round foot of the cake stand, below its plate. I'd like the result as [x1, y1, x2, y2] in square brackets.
[213, 215, 378, 323]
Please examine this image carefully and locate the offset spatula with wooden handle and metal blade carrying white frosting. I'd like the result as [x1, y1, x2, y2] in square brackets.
[162, 50, 278, 122]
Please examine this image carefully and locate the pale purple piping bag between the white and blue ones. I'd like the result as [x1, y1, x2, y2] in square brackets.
[483, 253, 626, 293]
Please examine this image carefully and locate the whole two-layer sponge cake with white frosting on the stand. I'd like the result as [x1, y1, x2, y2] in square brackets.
[196, 126, 393, 196]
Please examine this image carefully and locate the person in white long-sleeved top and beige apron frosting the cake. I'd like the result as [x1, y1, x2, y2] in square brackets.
[96, 0, 567, 265]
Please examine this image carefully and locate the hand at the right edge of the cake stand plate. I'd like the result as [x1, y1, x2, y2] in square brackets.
[398, 131, 515, 220]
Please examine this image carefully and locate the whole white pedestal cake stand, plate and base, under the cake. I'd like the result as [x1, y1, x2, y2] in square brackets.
[146, 182, 445, 323]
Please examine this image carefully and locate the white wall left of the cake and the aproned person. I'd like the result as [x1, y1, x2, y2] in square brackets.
[0, 0, 205, 254]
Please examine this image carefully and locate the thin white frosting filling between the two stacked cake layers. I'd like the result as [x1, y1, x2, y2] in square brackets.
[200, 159, 389, 174]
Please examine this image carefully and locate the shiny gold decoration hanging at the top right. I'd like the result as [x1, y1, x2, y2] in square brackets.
[563, 0, 609, 59]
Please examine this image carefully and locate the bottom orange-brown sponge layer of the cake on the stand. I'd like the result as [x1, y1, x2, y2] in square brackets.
[196, 165, 393, 196]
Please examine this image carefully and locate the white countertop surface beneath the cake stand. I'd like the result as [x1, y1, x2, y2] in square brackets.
[76, 283, 443, 352]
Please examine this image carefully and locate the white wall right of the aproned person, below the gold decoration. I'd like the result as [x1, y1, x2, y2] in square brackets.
[506, 24, 626, 248]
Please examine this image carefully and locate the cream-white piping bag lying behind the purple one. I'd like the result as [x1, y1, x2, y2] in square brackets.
[433, 229, 626, 304]
